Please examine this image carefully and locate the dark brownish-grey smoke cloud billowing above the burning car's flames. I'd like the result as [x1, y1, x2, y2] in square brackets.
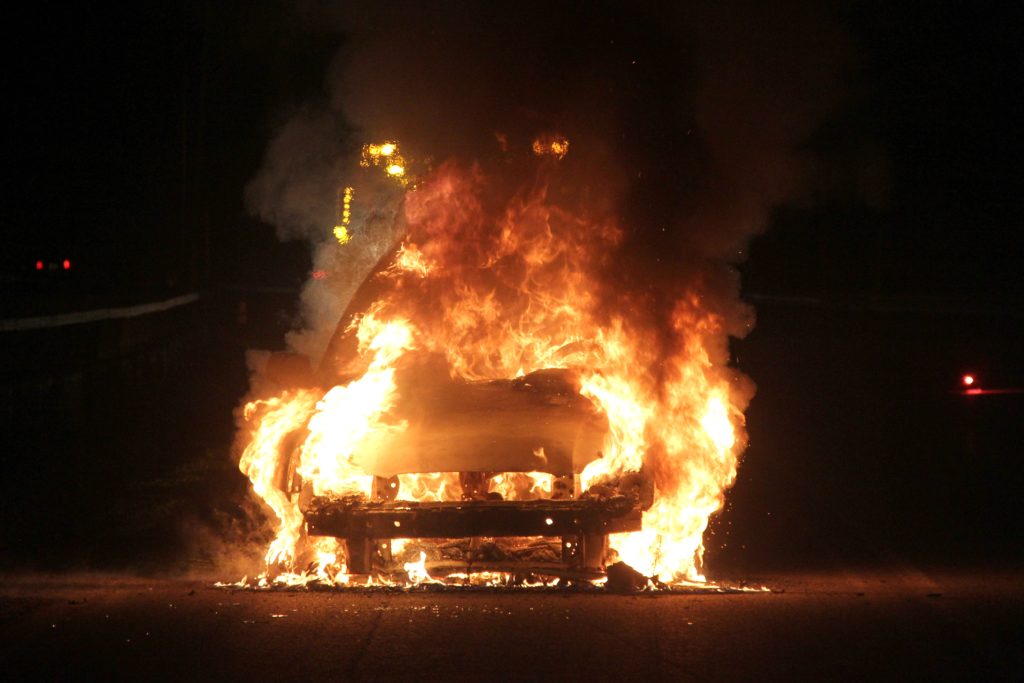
[247, 2, 849, 359]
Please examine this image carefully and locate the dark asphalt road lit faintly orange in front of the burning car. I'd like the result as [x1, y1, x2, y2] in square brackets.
[0, 569, 1024, 681]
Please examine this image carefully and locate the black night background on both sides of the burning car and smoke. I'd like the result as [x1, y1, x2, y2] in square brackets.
[0, 2, 1024, 574]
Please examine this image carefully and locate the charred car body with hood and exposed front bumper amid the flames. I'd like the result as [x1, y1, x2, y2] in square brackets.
[256, 241, 653, 579]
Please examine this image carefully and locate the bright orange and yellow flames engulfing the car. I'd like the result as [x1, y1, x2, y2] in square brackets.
[240, 137, 752, 586]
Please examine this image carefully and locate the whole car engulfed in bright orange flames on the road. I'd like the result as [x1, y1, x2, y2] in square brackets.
[240, 143, 752, 585]
